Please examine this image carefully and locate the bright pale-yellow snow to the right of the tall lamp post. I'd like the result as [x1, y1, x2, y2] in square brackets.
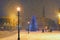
[21, 31, 60, 40]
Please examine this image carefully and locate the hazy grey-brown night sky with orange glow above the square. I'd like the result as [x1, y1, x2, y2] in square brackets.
[0, 0, 60, 20]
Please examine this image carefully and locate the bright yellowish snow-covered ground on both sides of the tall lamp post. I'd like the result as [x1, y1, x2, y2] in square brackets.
[0, 31, 60, 40]
